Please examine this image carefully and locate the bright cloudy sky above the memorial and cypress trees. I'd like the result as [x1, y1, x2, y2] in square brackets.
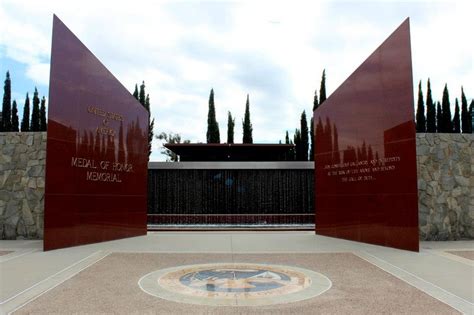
[0, 0, 474, 160]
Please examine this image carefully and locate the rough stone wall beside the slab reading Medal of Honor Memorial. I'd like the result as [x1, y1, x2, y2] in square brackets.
[0, 132, 46, 239]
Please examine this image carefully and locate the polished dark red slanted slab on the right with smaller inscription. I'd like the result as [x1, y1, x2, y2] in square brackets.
[314, 19, 419, 251]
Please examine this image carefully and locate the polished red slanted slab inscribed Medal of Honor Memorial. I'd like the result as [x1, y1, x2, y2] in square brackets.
[44, 16, 148, 250]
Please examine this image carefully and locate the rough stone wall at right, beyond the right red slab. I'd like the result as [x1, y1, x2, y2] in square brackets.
[417, 133, 474, 241]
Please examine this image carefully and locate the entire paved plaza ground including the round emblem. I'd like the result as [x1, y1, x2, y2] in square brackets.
[0, 232, 474, 314]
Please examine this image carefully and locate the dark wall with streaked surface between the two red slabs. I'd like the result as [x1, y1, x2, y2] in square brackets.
[148, 169, 314, 225]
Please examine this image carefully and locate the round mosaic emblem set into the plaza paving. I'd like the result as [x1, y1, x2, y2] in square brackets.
[138, 263, 331, 306]
